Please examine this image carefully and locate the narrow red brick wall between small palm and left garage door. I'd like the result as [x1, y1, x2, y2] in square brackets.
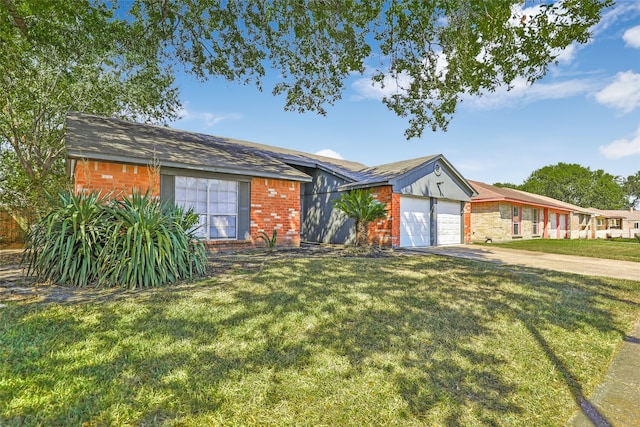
[367, 186, 400, 247]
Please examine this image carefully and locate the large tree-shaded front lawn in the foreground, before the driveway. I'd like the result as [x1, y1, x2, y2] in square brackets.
[0, 256, 640, 426]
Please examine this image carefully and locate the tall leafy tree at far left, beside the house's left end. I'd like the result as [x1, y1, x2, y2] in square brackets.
[0, 0, 179, 221]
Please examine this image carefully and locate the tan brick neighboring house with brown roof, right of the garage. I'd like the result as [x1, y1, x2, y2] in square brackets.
[469, 181, 580, 242]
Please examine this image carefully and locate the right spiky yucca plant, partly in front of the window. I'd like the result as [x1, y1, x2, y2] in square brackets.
[99, 193, 206, 288]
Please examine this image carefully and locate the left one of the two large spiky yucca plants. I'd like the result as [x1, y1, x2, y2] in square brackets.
[22, 192, 105, 286]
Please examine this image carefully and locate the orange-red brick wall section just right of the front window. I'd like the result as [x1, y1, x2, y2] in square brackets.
[250, 178, 300, 251]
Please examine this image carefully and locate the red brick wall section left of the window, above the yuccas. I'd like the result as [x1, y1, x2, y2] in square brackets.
[73, 160, 160, 197]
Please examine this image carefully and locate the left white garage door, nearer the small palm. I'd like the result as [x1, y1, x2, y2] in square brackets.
[400, 197, 431, 247]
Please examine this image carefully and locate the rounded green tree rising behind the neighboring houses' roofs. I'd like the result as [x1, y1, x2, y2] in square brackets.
[518, 162, 625, 209]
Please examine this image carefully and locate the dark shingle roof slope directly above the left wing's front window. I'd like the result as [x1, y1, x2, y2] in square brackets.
[65, 113, 311, 182]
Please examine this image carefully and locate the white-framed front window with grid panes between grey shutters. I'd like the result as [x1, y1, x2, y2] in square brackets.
[175, 176, 238, 240]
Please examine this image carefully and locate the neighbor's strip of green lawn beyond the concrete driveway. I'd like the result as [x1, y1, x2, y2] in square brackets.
[477, 239, 640, 262]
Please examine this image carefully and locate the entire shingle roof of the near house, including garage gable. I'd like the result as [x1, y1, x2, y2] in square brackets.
[66, 113, 473, 194]
